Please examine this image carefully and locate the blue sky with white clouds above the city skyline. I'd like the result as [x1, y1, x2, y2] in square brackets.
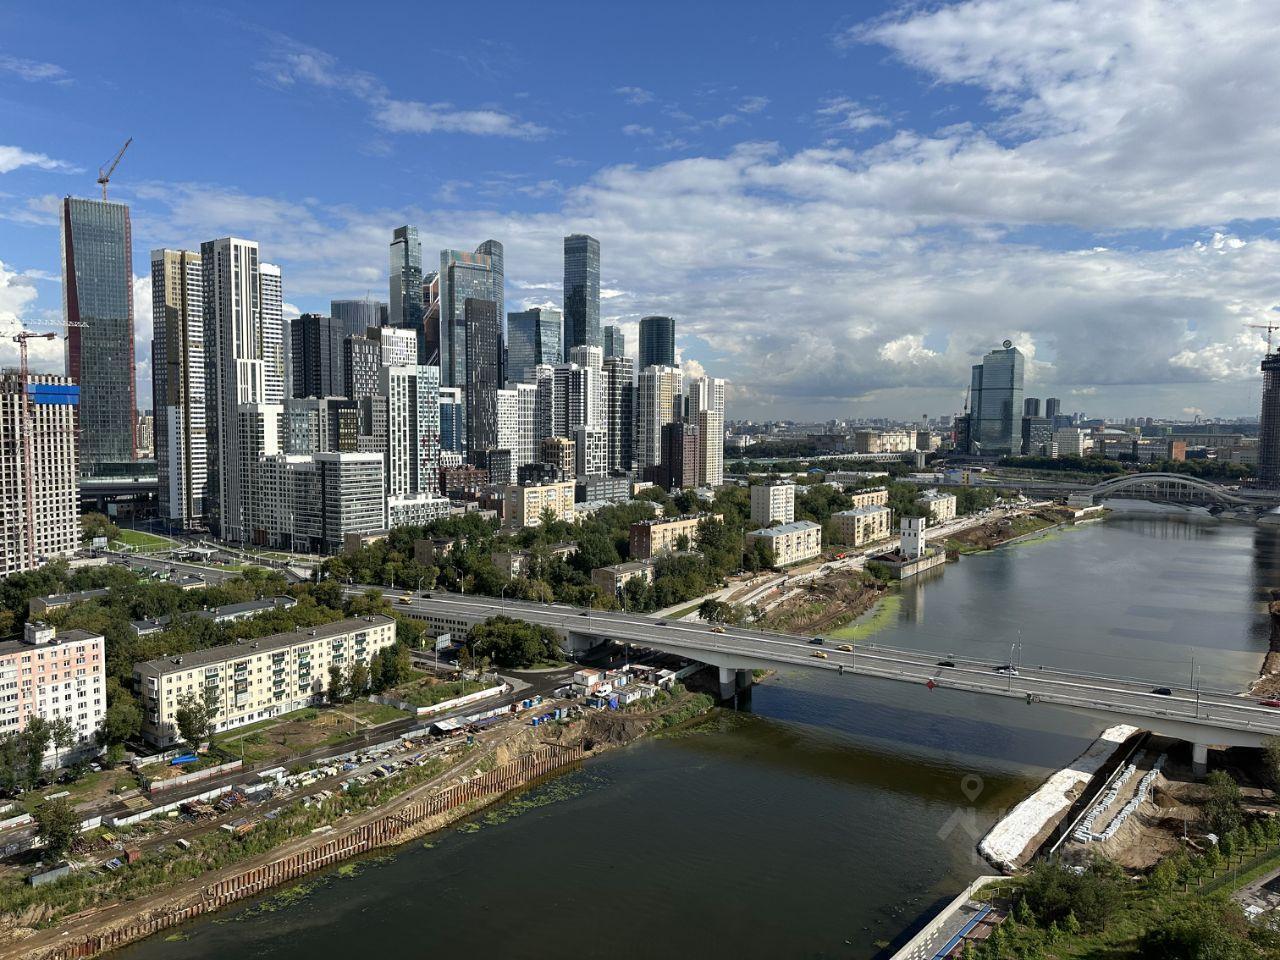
[0, 0, 1280, 419]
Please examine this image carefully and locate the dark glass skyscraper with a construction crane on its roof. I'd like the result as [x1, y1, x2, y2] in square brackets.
[61, 197, 138, 465]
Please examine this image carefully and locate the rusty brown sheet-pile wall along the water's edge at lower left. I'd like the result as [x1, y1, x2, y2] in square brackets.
[22, 746, 584, 960]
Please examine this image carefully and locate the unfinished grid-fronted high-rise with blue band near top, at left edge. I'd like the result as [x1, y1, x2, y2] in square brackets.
[0, 372, 81, 570]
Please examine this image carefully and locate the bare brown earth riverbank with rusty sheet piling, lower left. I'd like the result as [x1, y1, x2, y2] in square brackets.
[0, 690, 713, 960]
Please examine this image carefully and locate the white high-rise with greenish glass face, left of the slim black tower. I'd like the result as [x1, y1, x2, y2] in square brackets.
[378, 364, 440, 497]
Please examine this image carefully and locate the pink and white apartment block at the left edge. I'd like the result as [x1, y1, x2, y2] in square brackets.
[0, 624, 106, 763]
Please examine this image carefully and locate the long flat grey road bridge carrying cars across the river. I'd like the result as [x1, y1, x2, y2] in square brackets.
[373, 588, 1280, 771]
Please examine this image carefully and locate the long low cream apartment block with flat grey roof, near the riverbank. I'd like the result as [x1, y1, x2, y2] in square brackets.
[133, 614, 396, 746]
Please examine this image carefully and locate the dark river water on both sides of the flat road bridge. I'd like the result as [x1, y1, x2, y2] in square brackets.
[120, 506, 1280, 960]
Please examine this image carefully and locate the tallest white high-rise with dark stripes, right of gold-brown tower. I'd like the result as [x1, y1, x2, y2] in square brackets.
[200, 237, 282, 540]
